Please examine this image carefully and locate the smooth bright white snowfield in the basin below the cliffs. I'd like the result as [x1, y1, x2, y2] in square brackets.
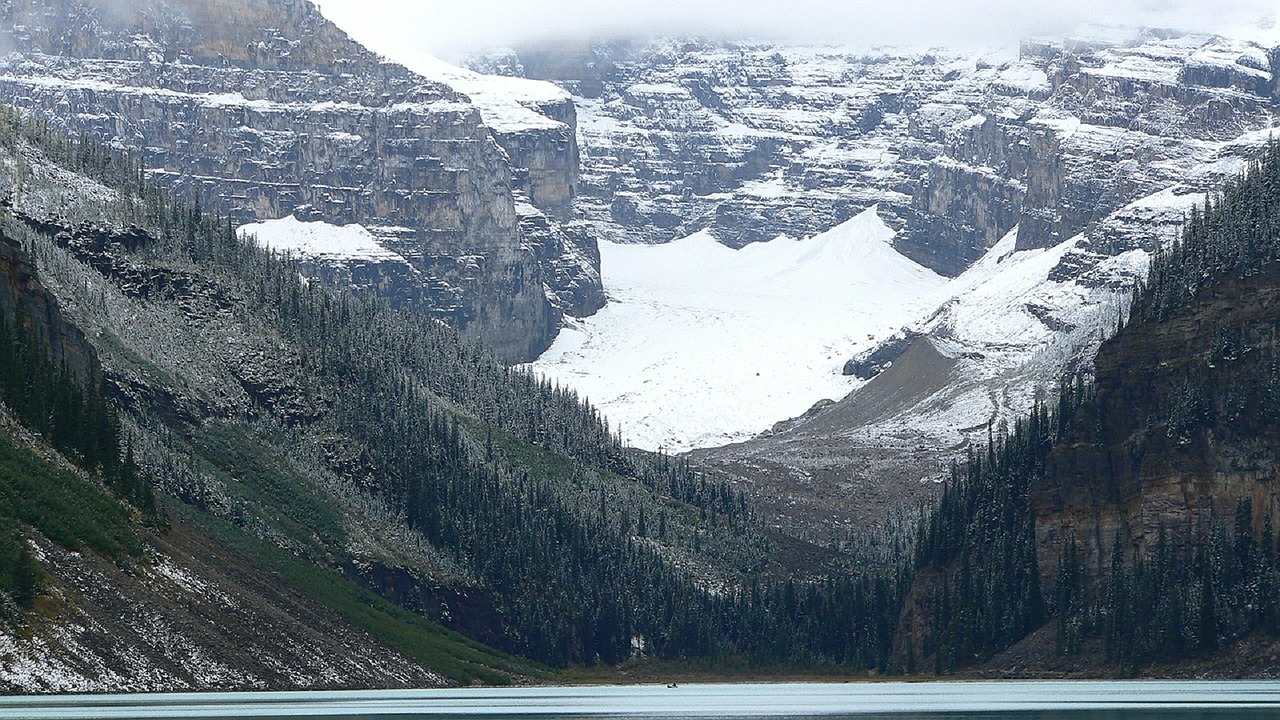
[531, 208, 946, 450]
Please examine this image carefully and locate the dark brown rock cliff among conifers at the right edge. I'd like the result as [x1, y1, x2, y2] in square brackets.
[1032, 266, 1280, 589]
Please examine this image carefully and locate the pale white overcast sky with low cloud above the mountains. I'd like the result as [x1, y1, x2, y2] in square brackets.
[316, 0, 1280, 58]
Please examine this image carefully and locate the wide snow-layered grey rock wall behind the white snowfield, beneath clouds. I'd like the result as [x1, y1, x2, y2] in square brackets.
[477, 32, 1276, 275]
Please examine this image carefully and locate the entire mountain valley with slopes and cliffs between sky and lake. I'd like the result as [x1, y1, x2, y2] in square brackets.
[0, 0, 1280, 693]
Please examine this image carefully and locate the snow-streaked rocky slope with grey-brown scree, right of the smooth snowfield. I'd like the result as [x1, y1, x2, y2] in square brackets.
[695, 144, 1266, 538]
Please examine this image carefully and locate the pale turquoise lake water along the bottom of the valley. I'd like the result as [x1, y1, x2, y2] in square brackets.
[0, 680, 1280, 720]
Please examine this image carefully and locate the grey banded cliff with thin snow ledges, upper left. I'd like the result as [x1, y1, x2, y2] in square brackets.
[0, 0, 577, 360]
